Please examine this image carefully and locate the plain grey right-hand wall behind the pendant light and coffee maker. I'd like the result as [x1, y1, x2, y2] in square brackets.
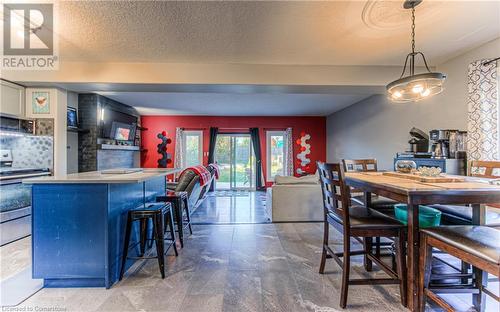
[327, 38, 500, 169]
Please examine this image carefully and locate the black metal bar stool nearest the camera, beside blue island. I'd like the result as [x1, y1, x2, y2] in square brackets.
[119, 203, 178, 280]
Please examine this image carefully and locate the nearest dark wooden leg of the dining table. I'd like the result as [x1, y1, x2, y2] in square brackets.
[407, 203, 420, 311]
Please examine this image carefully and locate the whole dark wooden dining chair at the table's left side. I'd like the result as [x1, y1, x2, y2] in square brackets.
[318, 162, 406, 308]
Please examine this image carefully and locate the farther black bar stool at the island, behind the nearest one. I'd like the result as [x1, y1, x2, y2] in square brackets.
[156, 191, 193, 248]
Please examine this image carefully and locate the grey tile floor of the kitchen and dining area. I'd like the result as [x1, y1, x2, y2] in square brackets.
[3, 223, 498, 312]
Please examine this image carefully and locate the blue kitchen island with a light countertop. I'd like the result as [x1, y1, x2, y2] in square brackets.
[23, 169, 179, 288]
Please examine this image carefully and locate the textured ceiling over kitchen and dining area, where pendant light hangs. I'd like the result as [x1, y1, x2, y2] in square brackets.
[54, 0, 500, 65]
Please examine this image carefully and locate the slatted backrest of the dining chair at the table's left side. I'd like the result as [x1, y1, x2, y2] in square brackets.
[317, 161, 351, 229]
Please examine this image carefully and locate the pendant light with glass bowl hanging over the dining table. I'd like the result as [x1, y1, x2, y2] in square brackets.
[386, 0, 446, 103]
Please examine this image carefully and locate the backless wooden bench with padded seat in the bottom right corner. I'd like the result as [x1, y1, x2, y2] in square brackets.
[419, 225, 500, 312]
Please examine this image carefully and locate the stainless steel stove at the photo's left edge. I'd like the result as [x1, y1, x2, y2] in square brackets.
[0, 150, 50, 246]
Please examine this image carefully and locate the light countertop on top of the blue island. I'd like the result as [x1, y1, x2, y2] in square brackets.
[23, 168, 181, 184]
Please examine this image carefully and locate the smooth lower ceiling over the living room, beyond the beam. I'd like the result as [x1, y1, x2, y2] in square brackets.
[99, 92, 369, 116]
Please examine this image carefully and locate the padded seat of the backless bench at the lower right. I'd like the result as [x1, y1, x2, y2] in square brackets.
[421, 225, 500, 265]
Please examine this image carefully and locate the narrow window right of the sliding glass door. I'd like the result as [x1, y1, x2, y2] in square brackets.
[266, 131, 286, 182]
